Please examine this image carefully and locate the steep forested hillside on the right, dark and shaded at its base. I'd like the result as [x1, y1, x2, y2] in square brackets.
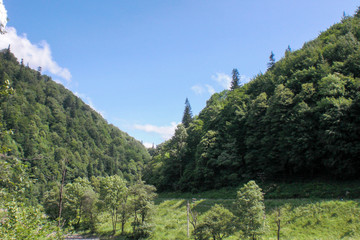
[146, 10, 360, 191]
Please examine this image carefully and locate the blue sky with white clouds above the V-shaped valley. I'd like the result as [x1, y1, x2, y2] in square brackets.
[0, 0, 360, 146]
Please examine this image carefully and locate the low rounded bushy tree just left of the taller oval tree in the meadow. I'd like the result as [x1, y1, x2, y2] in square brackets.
[194, 204, 235, 240]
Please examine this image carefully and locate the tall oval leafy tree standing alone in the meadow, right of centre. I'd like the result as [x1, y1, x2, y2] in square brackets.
[235, 181, 265, 240]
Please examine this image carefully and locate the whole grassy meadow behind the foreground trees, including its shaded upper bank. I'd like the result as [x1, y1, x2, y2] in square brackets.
[91, 182, 360, 240]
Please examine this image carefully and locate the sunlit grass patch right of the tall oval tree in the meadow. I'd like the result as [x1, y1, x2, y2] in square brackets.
[265, 201, 360, 240]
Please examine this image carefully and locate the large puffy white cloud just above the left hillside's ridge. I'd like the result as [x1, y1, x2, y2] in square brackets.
[0, 27, 71, 82]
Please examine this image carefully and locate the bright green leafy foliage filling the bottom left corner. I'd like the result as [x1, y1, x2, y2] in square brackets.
[0, 148, 62, 240]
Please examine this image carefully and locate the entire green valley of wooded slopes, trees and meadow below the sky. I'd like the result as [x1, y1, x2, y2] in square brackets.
[0, 8, 360, 240]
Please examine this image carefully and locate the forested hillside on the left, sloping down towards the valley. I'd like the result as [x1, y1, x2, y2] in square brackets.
[0, 46, 149, 184]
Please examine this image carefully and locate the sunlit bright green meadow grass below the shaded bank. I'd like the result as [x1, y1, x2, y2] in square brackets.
[152, 199, 360, 240]
